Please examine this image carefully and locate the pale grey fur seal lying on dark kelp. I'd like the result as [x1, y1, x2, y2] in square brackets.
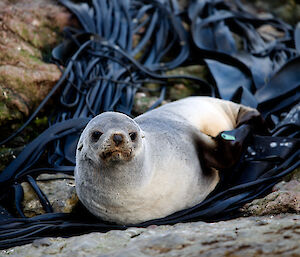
[75, 97, 259, 224]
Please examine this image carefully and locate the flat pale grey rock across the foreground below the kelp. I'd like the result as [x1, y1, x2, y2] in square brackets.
[0, 215, 300, 257]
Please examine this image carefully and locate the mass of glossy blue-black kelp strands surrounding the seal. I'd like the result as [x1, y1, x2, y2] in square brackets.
[0, 0, 300, 248]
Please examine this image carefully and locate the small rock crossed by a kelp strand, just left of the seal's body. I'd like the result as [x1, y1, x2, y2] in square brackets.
[21, 174, 78, 217]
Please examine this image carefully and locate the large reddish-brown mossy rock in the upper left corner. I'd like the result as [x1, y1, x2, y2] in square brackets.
[0, 0, 71, 127]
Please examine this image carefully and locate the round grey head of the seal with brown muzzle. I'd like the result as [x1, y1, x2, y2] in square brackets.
[77, 112, 143, 166]
